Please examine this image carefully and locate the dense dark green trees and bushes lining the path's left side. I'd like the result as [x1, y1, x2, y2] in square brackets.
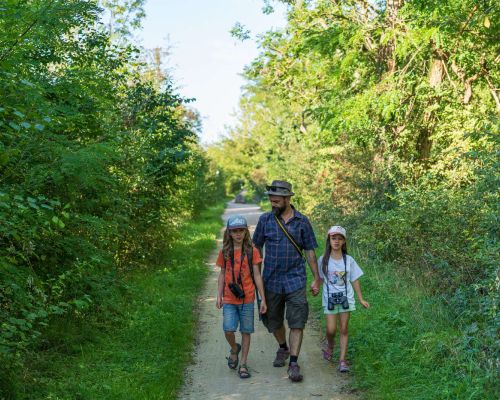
[0, 0, 223, 397]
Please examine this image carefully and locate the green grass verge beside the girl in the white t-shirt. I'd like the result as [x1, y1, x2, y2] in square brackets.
[310, 245, 498, 400]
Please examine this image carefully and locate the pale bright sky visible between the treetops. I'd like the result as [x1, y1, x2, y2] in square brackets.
[138, 0, 286, 144]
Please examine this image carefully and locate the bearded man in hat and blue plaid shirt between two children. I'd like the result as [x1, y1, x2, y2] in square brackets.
[253, 181, 320, 382]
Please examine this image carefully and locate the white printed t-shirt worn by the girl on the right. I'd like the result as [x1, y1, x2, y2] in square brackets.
[318, 255, 363, 307]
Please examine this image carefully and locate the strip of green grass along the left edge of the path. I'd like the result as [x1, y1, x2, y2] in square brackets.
[23, 204, 224, 400]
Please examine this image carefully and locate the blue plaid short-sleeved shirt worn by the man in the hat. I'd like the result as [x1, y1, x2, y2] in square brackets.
[253, 209, 318, 293]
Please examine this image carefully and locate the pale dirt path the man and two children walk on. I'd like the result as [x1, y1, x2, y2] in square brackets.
[179, 202, 355, 400]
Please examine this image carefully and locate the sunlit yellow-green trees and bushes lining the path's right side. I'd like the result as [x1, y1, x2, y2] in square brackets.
[209, 0, 500, 399]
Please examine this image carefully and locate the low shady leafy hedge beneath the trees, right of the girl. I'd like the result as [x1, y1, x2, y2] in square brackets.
[352, 134, 500, 382]
